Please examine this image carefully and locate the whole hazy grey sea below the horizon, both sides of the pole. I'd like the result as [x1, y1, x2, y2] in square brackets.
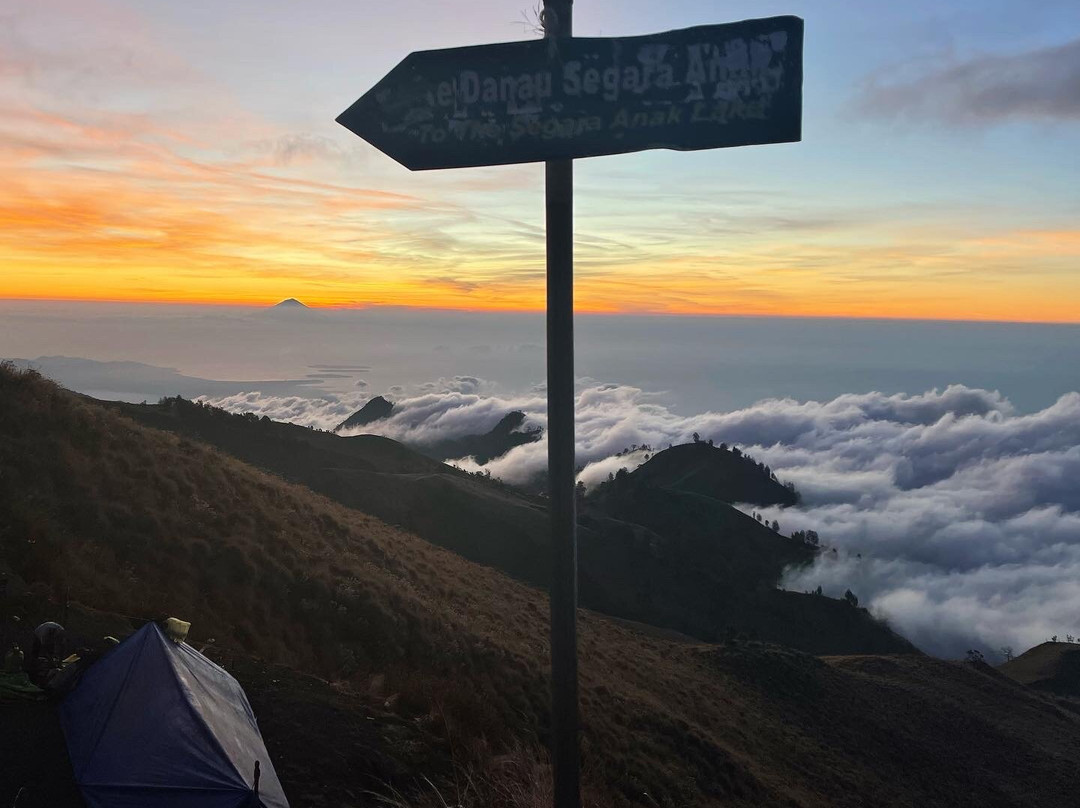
[0, 301, 1080, 414]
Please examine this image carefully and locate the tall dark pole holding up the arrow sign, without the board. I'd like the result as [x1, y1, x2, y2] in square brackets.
[543, 0, 581, 808]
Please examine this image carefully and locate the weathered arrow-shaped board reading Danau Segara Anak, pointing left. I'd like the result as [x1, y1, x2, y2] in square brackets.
[337, 16, 802, 170]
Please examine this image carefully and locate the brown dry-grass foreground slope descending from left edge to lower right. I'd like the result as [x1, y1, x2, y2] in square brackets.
[6, 371, 1080, 807]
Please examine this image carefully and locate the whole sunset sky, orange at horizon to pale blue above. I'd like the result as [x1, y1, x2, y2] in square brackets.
[0, 0, 1080, 322]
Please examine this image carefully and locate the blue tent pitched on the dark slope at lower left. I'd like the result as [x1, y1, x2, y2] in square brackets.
[60, 623, 288, 808]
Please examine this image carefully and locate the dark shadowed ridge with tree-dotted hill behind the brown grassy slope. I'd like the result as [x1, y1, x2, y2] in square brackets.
[109, 400, 913, 654]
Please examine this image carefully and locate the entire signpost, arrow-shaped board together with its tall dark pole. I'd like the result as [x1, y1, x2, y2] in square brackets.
[337, 0, 802, 808]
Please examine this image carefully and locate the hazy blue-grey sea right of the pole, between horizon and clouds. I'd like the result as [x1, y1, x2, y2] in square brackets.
[579, 318, 1080, 412]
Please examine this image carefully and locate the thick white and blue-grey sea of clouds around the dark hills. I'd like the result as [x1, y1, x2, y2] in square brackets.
[207, 376, 1080, 657]
